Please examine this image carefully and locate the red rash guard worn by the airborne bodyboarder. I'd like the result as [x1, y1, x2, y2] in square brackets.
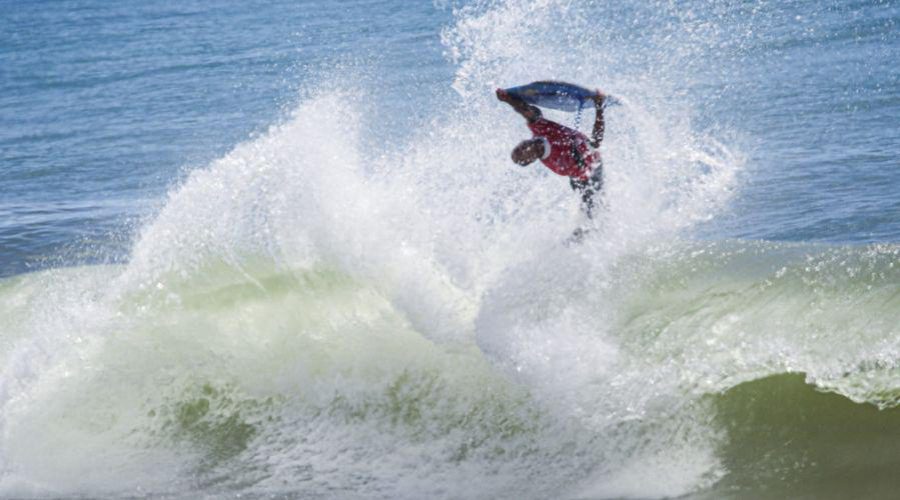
[528, 118, 600, 180]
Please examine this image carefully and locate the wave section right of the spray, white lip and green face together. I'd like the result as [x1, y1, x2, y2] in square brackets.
[620, 244, 900, 499]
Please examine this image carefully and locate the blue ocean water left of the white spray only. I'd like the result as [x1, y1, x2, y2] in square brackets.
[0, 1, 452, 275]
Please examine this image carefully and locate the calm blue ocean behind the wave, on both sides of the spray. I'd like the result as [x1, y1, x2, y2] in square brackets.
[0, 2, 900, 275]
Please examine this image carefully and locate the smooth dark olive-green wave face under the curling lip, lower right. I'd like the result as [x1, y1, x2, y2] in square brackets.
[697, 374, 900, 499]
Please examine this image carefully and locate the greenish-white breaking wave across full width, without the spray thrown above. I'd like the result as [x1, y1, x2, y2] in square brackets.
[0, 242, 900, 498]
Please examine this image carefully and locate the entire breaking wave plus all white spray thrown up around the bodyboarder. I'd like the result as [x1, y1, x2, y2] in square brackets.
[0, 0, 900, 499]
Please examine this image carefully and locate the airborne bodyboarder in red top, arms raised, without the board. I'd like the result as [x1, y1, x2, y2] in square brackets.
[497, 89, 606, 221]
